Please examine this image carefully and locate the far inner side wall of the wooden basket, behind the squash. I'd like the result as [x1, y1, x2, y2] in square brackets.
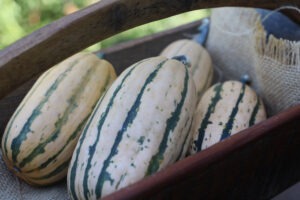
[101, 20, 201, 74]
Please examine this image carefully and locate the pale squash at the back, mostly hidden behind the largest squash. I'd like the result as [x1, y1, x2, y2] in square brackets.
[160, 39, 213, 101]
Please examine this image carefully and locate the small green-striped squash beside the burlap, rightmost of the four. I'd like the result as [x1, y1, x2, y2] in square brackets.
[190, 81, 266, 154]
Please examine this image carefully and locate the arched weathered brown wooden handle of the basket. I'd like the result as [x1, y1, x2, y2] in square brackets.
[0, 0, 300, 99]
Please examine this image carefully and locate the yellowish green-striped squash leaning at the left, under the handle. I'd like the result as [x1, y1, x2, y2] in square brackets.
[2, 53, 116, 185]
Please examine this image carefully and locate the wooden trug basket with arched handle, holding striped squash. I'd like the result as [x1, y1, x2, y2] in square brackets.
[0, 0, 300, 200]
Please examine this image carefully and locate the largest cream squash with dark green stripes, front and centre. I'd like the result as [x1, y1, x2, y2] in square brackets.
[68, 57, 196, 199]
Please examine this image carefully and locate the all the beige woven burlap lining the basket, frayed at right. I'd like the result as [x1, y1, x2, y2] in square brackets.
[0, 8, 300, 200]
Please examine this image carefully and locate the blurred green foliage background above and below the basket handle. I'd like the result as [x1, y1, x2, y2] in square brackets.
[0, 0, 209, 51]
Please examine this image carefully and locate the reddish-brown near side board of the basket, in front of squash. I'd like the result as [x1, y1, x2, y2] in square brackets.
[103, 105, 300, 200]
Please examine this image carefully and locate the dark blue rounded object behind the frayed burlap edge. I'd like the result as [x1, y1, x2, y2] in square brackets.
[256, 9, 300, 41]
